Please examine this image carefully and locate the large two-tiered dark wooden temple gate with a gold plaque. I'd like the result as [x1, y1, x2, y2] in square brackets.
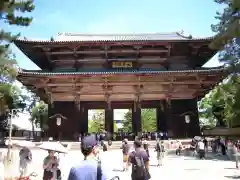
[15, 33, 225, 139]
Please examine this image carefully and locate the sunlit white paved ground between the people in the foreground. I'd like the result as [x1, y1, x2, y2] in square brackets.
[0, 150, 240, 180]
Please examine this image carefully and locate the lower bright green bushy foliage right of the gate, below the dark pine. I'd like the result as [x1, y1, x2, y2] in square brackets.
[199, 76, 240, 127]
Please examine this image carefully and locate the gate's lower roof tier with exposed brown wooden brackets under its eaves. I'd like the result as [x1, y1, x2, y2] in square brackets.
[18, 68, 226, 102]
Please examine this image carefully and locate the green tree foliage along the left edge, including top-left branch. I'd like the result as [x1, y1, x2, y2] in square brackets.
[0, 0, 34, 132]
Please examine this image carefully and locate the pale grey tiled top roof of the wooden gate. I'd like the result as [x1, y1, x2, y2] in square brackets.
[17, 32, 212, 43]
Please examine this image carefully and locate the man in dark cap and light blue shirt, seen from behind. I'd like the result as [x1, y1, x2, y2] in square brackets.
[68, 136, 111, 180]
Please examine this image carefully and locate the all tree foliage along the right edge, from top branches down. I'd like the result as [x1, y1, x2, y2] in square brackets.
[199, 0, 240, 127]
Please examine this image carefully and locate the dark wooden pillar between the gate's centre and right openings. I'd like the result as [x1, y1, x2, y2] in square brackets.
[132, 104, 142, 135]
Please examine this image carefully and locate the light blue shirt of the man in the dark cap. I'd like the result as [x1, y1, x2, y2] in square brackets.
[68, 159, 108, 180]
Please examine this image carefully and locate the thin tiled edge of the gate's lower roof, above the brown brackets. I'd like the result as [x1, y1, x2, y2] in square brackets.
[19, 68, 225, 76]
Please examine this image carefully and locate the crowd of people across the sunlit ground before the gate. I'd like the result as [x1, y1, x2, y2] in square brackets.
[2, 134, 240, 180]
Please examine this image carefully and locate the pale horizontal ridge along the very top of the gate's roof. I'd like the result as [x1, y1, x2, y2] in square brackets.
[57, 31, 179, 36]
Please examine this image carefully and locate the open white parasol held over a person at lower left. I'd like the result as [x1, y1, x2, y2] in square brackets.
[38, 141, 68, 153]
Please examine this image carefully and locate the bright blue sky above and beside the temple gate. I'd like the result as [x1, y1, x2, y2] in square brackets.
[0, 0, 225, 69]
